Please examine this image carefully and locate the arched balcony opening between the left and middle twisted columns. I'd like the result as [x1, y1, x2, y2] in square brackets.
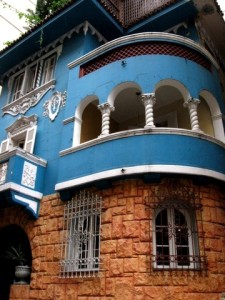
[110, 83, 145, 133]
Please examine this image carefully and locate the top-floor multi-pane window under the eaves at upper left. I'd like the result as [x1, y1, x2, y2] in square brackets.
[9, 53, 56, 102]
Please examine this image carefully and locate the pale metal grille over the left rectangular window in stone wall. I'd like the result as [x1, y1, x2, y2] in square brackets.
[60, 191, 102, 277]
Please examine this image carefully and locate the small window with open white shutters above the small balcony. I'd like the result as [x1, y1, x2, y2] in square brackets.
[0, 115, 37, 154]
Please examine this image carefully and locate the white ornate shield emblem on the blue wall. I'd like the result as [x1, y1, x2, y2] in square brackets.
[43, 91, 67, 121]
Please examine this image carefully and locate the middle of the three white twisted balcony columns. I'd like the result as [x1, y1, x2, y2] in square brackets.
[141, 93, 156, 128]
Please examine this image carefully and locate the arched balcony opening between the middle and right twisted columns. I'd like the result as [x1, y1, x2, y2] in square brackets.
[154, 80, 191, 129]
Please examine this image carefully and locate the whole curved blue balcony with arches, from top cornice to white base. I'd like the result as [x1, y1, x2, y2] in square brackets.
[56, 33, 225, 195]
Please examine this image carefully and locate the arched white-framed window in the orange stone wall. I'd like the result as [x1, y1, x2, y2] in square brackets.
[153, 203, 200, 269]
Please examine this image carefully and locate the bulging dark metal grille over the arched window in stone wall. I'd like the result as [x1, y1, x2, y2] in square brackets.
[146, 180, 206, 270]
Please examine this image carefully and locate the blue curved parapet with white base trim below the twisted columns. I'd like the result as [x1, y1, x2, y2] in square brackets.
[56, 128, 225, 191]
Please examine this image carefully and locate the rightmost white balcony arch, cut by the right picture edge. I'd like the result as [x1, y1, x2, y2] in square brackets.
[199, 90, 225, 142]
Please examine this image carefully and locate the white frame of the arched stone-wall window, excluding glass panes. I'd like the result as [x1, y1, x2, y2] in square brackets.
[152, 205, 200, 269]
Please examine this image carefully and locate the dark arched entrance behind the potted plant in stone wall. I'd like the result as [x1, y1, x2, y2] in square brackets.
[0, 225, 32, 300]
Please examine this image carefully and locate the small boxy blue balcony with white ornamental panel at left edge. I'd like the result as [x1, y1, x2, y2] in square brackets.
[0, 148, 47, 218]
